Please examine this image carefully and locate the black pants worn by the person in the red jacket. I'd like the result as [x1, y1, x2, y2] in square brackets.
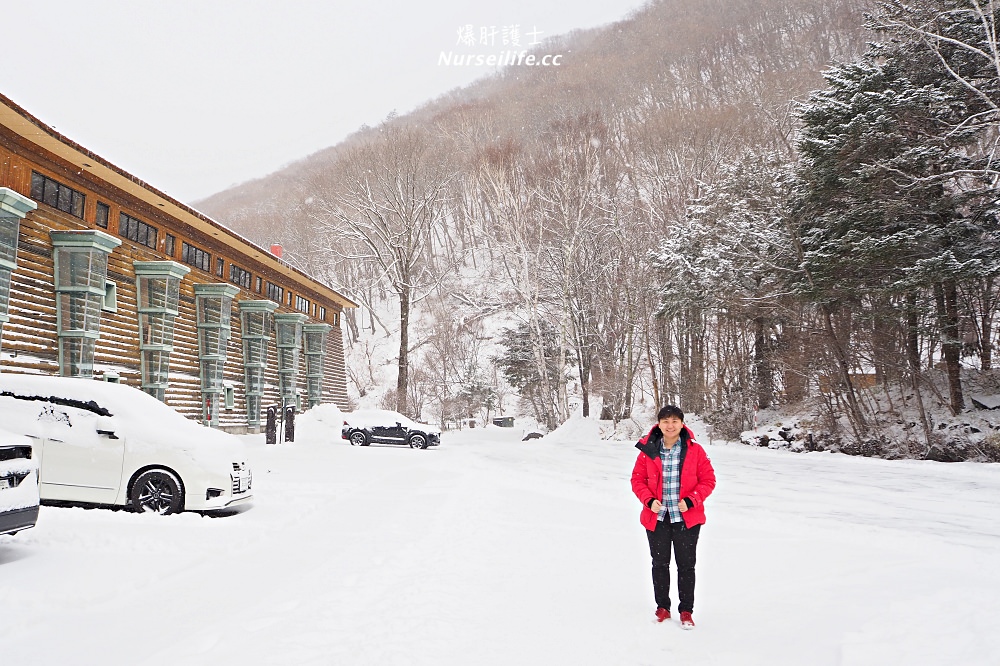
[646, 521, 701, 613]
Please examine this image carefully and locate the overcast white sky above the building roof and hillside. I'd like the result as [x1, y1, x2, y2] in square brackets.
[0, 0, 645, 202]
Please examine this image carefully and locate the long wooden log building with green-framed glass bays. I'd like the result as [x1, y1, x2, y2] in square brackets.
[0, 95, 356, 432]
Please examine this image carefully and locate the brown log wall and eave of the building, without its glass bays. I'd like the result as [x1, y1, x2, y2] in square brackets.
[0, 96, 355, 432]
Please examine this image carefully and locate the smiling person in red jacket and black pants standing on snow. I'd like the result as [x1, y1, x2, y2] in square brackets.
[632, 405, 715, 629]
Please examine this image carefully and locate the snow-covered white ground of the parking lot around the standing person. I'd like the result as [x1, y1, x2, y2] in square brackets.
[0, 415, 1000, 666]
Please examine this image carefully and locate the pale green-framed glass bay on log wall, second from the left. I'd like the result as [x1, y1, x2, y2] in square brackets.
[49, 231, 121, 379]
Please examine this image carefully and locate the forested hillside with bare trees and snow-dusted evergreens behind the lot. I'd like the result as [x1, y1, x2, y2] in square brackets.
[197, 0, 997, 457]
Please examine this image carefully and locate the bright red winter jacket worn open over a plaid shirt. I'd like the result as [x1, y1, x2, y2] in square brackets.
[632, 426, 715, 532]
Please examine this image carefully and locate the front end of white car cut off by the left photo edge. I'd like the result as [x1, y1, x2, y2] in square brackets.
[0, 430, 38, 534]
